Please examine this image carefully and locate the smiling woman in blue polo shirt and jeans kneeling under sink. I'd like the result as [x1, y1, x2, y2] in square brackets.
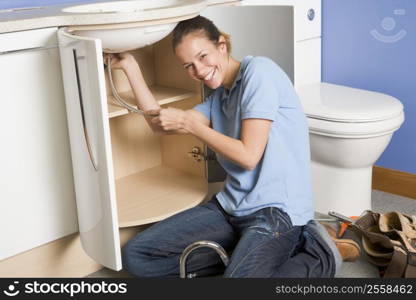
[107, 16, 336, 277]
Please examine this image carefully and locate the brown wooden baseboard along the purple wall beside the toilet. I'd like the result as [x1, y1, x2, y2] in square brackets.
[373, 166, 416, 199]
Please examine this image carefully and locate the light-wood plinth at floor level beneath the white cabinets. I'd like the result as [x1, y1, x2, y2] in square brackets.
[0, 226, 144, 278]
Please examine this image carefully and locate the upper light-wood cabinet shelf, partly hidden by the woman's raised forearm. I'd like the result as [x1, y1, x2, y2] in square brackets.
[107, 85, 197, 118]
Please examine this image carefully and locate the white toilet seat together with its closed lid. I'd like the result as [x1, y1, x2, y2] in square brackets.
[297, 82, 404, 138]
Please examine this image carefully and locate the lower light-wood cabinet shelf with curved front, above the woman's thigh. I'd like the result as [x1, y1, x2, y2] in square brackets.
[116, 166, 208, 227]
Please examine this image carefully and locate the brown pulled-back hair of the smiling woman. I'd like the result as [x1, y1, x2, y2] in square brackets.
[172, 16, 231, 53]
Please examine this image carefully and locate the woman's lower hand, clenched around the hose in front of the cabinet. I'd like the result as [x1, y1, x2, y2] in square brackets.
[146, 107, 191, 134]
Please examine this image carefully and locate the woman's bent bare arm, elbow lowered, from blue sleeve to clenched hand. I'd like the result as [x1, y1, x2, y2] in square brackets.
[152, 108, 272, 170]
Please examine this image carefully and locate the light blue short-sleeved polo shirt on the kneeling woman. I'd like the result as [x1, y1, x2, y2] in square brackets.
[194, 56, 313, 225]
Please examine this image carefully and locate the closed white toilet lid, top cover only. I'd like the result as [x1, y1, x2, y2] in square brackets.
[296, 82, 403, 123]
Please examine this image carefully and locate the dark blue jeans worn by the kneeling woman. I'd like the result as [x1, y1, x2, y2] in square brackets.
[123, 197, 338, 278]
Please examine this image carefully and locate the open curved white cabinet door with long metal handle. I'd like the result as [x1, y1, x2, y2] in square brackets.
[58, 28, 121, 271]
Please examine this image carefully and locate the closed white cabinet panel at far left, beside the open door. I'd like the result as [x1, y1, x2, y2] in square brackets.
[0, 28, 78, 262]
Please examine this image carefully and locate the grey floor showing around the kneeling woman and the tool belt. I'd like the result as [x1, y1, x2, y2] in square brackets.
[87, 190, 416, 278]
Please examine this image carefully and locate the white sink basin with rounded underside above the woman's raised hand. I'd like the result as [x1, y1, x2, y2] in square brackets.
[63, 0, 207, 53]
